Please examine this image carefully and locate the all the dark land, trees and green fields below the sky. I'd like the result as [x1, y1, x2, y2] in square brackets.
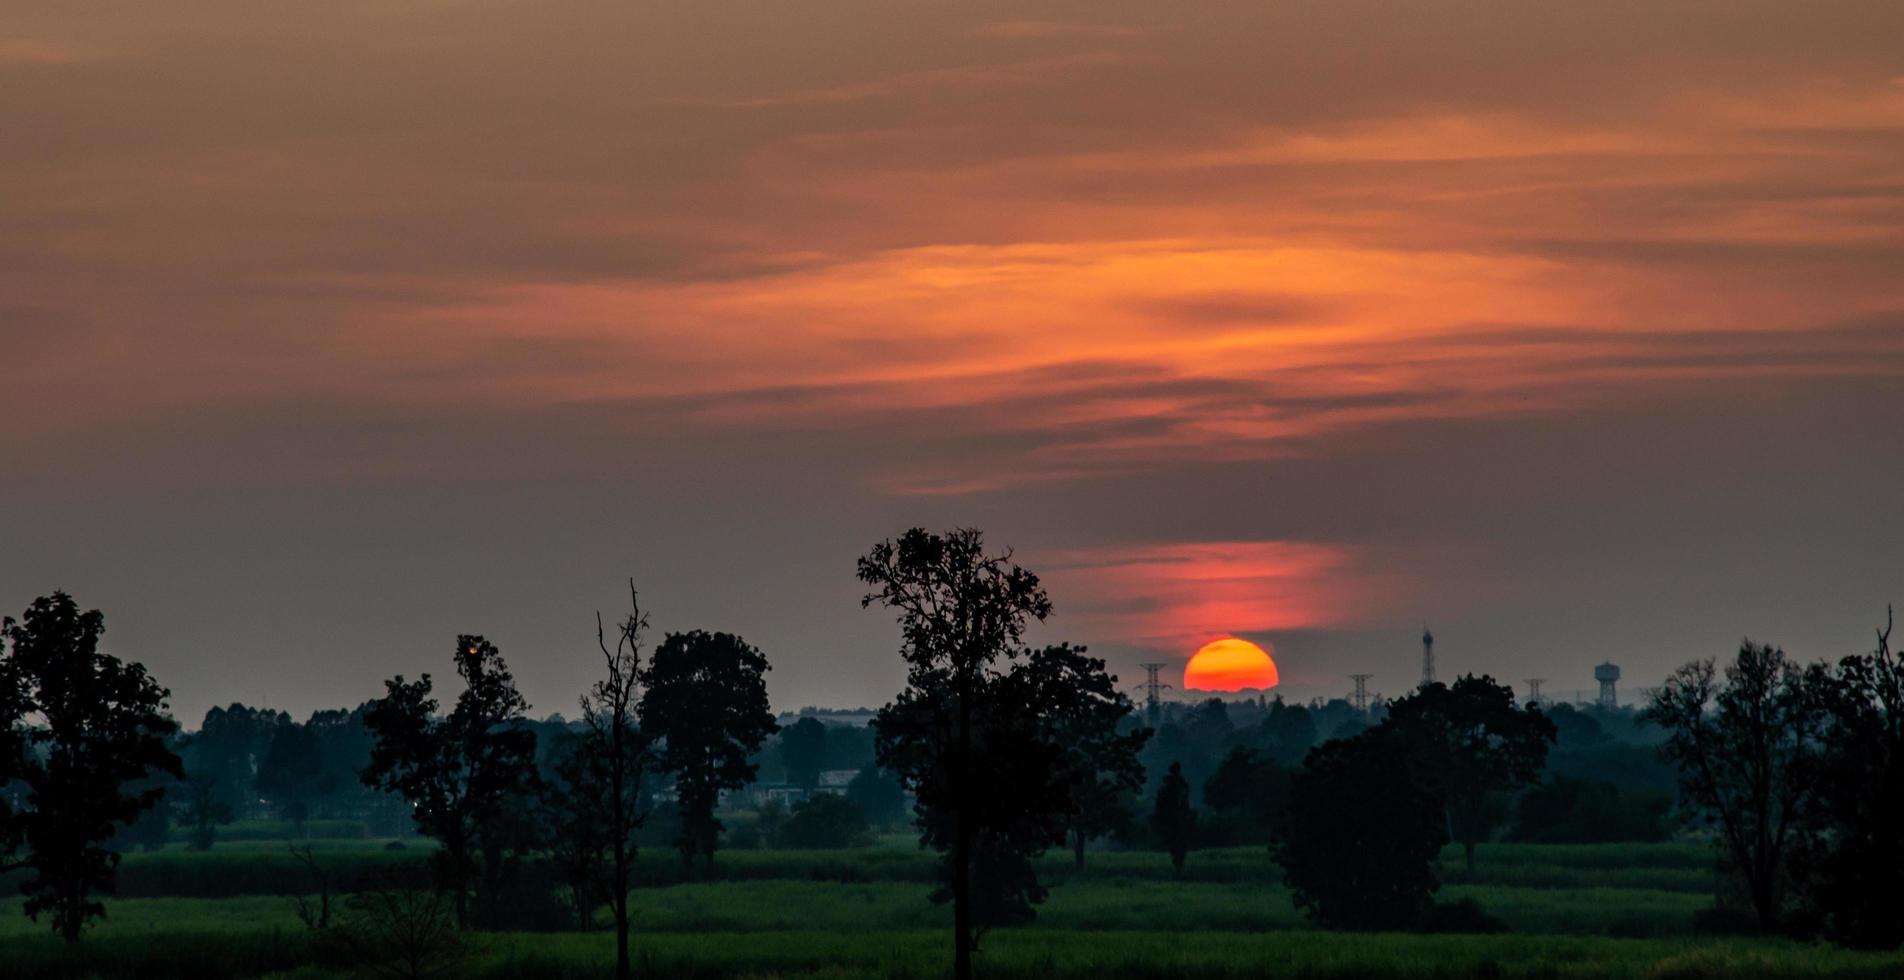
[0, 531, 1904, 978]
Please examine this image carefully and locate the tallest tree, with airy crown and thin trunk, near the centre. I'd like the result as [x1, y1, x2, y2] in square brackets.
[857, 527, 1051, 980]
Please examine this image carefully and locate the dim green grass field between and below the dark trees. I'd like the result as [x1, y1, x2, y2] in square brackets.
[0, 839, 1904, 980]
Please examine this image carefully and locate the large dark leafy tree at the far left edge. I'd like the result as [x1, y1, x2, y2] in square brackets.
[0, 592, 183, 944]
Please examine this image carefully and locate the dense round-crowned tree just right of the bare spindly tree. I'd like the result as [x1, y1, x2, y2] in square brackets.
[642, 630, 779, 868]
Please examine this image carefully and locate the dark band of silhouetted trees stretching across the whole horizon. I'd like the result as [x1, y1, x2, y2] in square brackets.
[0, 529, 1904, 976]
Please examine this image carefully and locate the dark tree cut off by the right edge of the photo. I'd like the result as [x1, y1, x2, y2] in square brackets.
[1792, 611, 1904, 950]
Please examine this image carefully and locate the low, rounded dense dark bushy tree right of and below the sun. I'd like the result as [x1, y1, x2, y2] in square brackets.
[1270, 727, 1447, 931]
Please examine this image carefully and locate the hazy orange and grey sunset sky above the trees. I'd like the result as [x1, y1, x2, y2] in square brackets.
[0, 0, 1904, 723]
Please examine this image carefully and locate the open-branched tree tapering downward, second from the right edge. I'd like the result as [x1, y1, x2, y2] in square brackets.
[1645, 641, 1822, 931]
